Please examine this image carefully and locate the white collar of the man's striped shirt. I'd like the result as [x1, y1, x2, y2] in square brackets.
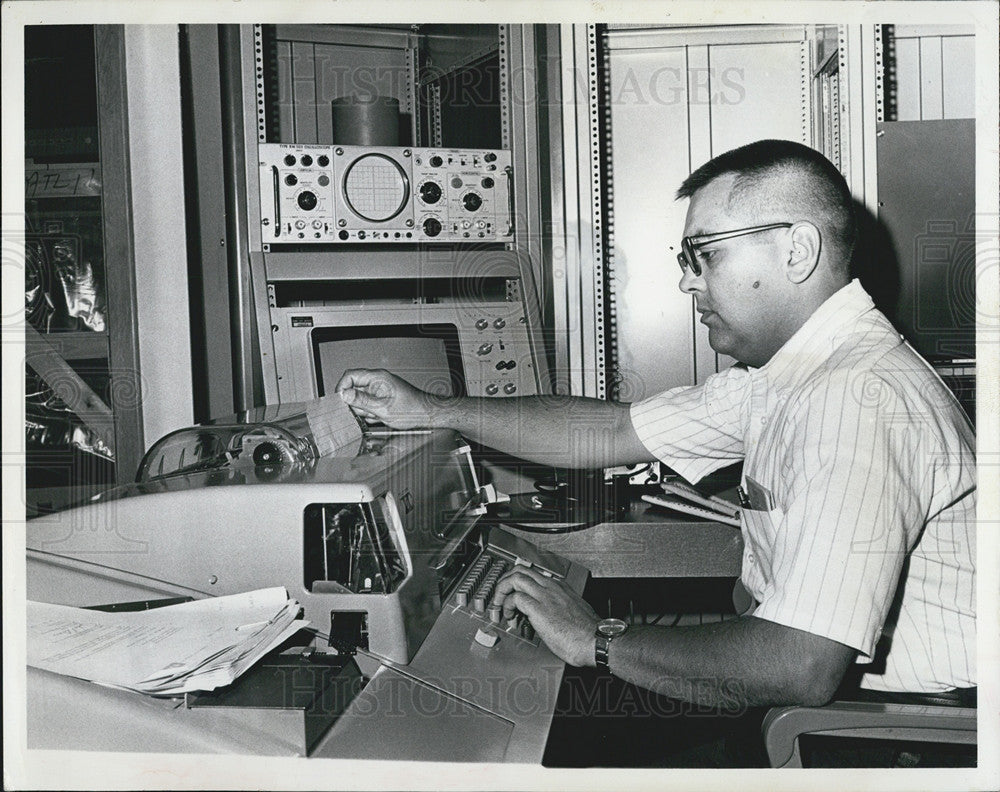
[751, 279, 875, 387]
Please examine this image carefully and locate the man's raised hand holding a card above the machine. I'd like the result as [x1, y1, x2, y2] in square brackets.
[337, 369, 435, 429]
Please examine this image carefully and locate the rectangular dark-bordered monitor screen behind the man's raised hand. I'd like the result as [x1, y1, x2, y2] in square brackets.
[311, 323, 466, 396]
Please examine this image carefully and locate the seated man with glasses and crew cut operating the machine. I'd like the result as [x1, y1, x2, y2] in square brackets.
[338, 140, 976, 760]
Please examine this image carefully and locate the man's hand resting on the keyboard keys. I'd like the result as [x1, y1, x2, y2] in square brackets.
[493, 566, 600, 666]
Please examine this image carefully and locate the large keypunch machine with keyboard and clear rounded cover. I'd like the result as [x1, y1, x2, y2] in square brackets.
[27, 405, 588, 763]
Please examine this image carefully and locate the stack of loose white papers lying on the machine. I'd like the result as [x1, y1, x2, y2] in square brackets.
[27, 587, 308, 696]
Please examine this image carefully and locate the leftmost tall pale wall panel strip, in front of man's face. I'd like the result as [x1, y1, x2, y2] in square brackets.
[611, 47, 692, 401]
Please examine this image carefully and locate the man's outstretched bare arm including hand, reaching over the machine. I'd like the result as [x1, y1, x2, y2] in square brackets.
[337, 369, 653, 468]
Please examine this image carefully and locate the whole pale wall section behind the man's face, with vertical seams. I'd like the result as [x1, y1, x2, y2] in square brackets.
[609, 26, 810, 401]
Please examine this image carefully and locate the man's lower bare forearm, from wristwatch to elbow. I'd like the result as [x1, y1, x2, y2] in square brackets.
[610, 617, 851, 711]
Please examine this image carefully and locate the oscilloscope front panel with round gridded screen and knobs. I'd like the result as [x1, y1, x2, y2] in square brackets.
[258, 143, 514, 246]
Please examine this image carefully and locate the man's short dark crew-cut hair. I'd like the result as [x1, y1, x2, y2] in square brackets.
[677, 140, 857, 268]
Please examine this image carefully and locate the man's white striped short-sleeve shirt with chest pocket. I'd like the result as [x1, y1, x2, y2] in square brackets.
[631, 281, 976, 692]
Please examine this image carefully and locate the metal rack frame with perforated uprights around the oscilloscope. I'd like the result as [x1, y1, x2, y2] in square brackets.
[222, 25, 549, 409]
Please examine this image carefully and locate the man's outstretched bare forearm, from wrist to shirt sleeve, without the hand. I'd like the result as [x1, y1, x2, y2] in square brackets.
[420, 396, 651, 468]
